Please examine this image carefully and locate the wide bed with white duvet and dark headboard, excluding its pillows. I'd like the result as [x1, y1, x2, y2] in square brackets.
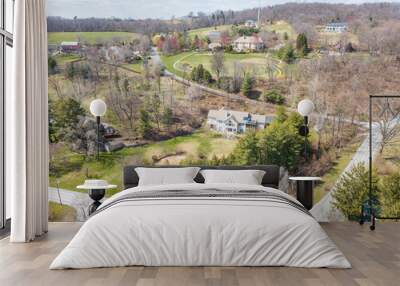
[50, 166, 351, 269]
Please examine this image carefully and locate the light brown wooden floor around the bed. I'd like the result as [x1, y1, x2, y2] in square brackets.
[0, 222, 400, 286]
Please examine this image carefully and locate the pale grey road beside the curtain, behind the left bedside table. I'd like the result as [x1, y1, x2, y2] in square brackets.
[49, 187, 93, 221]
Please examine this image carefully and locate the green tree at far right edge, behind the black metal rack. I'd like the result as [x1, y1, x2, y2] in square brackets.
[380, 173, 400, 217]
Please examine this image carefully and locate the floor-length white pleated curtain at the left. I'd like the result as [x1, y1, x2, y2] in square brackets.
[6, 0, 48, 242]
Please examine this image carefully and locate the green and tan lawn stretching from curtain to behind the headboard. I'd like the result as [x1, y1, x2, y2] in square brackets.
[50, 131, 236, 195]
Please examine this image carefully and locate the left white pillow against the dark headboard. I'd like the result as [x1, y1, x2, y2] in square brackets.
[135, 167, 200, 186]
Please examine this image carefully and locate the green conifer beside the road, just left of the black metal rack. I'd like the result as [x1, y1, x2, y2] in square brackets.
[332, 163, 379, 218]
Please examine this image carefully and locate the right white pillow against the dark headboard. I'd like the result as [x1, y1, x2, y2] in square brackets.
[200, 170, 265, 185]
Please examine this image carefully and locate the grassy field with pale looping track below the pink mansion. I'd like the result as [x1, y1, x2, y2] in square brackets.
[162, 52, 284, 77]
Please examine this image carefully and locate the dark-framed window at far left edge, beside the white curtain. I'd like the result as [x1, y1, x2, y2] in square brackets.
[0, 0, 14, 229]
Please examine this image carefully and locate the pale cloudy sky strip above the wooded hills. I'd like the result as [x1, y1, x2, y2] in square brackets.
[47, 0, 398, 19]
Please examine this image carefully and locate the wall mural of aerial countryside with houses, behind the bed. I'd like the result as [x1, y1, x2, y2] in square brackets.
[48, 0, 400, 221]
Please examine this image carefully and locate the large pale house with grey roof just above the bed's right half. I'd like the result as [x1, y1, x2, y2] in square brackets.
[207, 108, 274, 134]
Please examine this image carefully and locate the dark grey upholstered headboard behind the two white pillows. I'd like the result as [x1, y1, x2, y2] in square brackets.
[123, 165, 280, 190]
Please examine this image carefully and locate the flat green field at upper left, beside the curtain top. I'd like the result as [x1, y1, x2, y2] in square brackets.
[48, 32, 139, 44]
